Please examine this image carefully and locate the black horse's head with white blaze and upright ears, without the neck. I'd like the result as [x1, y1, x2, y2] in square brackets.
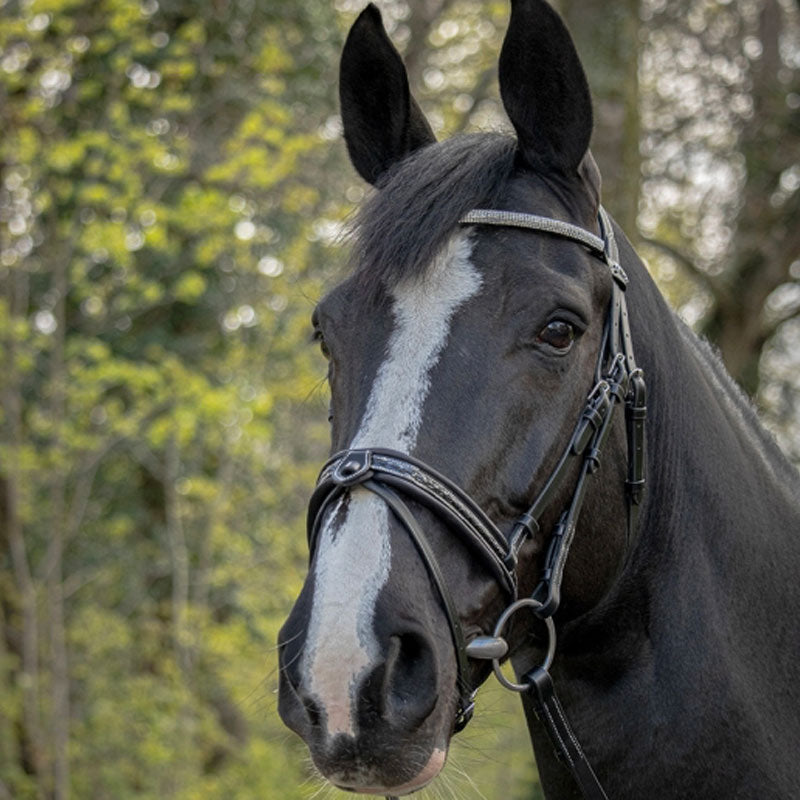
[280, 0, 629, 794]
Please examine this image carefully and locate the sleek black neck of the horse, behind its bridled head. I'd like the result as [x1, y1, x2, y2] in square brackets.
[523, 241, 800, 800]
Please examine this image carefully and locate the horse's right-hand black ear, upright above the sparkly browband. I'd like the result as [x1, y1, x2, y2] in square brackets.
[499, 0, 592, 174]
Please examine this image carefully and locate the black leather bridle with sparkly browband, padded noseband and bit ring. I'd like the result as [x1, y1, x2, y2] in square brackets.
[308, 208, 647, 800]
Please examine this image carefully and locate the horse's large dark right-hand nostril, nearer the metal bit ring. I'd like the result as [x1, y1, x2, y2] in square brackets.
[381, 632, 438, 728]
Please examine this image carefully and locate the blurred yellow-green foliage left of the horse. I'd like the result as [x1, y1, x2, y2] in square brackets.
[0, 0, 534, 800]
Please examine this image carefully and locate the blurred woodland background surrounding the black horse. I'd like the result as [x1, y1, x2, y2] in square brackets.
[0, 0, 800, 800]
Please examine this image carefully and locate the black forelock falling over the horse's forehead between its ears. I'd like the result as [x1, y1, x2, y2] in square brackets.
[352, 133, 517, 290]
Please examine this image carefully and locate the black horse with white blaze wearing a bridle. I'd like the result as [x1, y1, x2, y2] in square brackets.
[280, 0, 800, 800]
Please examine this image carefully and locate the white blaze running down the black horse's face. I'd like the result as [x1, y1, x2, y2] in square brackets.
[303, 233, 481, 736]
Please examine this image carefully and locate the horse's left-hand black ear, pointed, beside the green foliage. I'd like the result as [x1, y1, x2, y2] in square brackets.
[339, 3, 436, 184]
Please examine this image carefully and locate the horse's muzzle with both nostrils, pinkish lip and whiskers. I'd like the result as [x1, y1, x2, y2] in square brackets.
[278, 616, 455, 795]
